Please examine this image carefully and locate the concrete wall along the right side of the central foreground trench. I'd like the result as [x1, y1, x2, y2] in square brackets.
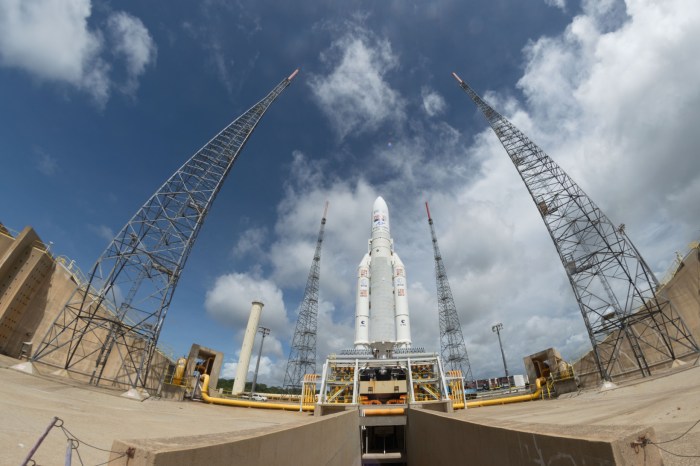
[407, 410, 663, 466]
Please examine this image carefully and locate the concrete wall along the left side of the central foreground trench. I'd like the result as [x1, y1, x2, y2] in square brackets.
[109, 408, 360, 466]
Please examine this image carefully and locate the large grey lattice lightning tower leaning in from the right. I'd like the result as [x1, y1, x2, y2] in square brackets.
[453, 73, 698, 381]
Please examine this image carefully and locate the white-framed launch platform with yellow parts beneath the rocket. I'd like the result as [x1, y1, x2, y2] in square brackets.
[314, 348, 456, 464]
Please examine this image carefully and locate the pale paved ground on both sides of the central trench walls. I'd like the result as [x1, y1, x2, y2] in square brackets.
[0, 356, 700, 466]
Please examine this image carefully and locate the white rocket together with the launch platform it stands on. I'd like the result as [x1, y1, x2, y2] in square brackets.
[303, 196, 465, 464]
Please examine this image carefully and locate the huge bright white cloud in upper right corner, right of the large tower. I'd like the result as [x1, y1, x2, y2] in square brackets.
[519, 0, 700, 270]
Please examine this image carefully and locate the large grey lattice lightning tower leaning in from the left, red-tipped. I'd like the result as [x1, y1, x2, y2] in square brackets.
[32, 70, 298, 388]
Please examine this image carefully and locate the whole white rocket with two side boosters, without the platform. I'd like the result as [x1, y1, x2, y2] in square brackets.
[355, 196, 411, 355]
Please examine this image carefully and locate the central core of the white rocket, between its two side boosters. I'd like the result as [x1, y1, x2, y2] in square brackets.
[369, 196, 396, 344]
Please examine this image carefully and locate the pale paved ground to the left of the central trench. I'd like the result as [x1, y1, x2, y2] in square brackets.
[0, 356, 313, 466]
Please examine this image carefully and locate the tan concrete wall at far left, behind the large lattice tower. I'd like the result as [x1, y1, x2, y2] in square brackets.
[0, 225, 170, 391]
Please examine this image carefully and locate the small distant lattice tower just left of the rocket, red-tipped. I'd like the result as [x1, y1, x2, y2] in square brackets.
[282, 201, 328, 391]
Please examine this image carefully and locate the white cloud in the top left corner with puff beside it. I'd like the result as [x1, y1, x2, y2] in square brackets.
[0, 0, 155, 105]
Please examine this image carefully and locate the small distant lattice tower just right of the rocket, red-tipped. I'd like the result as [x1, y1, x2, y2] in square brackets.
[425, 202, 474, 382]
